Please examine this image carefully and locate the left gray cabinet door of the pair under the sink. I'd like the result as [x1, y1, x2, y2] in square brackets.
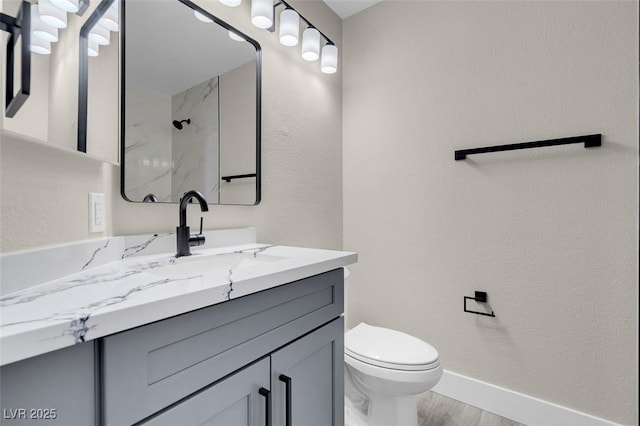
[142, 357, 270, 426]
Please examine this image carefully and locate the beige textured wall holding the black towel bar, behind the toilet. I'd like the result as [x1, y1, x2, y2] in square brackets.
[343, 1, 638, 424]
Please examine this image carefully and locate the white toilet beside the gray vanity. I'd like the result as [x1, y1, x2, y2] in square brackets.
[344, 268, 442, 426]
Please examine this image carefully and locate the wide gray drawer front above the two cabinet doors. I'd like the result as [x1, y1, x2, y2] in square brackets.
[102, 269, 343, 425]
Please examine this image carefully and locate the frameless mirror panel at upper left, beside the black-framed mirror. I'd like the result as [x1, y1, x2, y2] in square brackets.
[0, 0, 119, 164]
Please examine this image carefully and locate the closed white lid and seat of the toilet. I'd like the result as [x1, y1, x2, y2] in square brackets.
[344, 323, 440, 370]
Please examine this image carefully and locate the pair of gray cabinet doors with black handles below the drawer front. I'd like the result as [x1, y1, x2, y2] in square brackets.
[141, 318, 344, 426]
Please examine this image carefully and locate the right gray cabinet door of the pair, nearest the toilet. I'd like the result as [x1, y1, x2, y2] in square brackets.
[271, 317, 344, 426]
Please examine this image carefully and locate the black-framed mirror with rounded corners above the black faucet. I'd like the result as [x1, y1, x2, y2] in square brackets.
[120, 0, 261, 205]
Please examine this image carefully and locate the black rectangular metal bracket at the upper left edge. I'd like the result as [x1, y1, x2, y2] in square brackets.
[0, 0, 31, 118]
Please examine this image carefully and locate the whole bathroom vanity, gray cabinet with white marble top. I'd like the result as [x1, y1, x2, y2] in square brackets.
[0, 228, 357, 426]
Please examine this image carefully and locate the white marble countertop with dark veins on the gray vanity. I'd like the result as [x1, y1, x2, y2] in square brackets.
[0, 230, 357, 365]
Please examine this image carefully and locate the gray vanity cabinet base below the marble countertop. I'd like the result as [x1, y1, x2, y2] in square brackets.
[0, 268, 344, 426]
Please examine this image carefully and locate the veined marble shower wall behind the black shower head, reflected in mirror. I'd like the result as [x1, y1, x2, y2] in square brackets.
[171, 77, 220, 203]
